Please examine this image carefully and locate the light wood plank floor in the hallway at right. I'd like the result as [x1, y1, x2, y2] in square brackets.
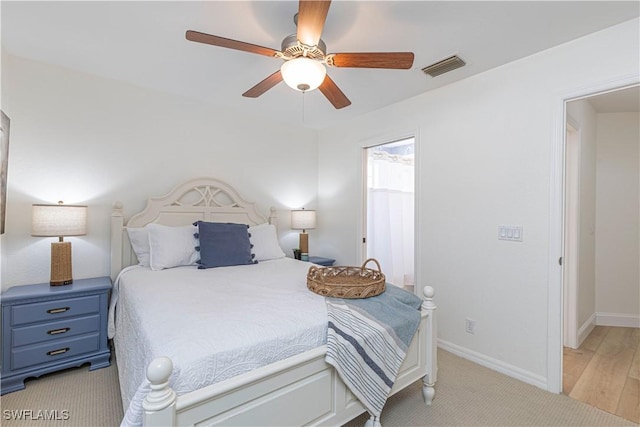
[562, 326, 640, 423]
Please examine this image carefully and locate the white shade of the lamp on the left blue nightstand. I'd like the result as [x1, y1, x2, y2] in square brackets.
[31, 204, 87, 237]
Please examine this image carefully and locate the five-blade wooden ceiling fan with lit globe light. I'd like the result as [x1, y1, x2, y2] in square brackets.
[186, 0, 413, 109]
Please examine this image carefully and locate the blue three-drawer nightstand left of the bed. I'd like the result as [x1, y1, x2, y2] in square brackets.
[1, 277, 111, 394]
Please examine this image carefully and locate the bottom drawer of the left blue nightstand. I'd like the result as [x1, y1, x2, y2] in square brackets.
[11, 333, 100, 369]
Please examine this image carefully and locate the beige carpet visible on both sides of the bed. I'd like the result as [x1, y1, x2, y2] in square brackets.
[0, 350, 637, 427]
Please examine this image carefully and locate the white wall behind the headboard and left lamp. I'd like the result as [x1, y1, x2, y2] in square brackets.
[2, 55, 317, 289]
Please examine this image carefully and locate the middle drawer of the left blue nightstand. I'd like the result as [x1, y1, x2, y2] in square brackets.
[12, 314, 100, 347]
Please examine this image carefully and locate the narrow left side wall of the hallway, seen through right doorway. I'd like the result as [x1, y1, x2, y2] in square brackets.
[567, 99, 597, 328]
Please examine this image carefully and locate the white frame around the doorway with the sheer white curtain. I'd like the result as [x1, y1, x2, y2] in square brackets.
[356, 129, 426, 297]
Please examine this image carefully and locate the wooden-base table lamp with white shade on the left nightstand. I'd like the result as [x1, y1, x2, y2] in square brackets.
[31, 202, 87, 286]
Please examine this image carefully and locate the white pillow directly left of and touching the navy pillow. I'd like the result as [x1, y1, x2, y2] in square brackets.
[147, 224, 199, 270]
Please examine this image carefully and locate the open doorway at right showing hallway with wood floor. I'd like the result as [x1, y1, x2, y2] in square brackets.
[562, 86, 640, 423]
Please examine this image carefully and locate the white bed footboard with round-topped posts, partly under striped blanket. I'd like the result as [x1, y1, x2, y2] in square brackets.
[143, 286, 438, 426]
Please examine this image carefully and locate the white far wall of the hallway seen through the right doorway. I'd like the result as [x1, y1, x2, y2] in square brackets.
[596, 113, 640, 327]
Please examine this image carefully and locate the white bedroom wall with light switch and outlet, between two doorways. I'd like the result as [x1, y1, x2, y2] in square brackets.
[318, 20, 640, 387]
